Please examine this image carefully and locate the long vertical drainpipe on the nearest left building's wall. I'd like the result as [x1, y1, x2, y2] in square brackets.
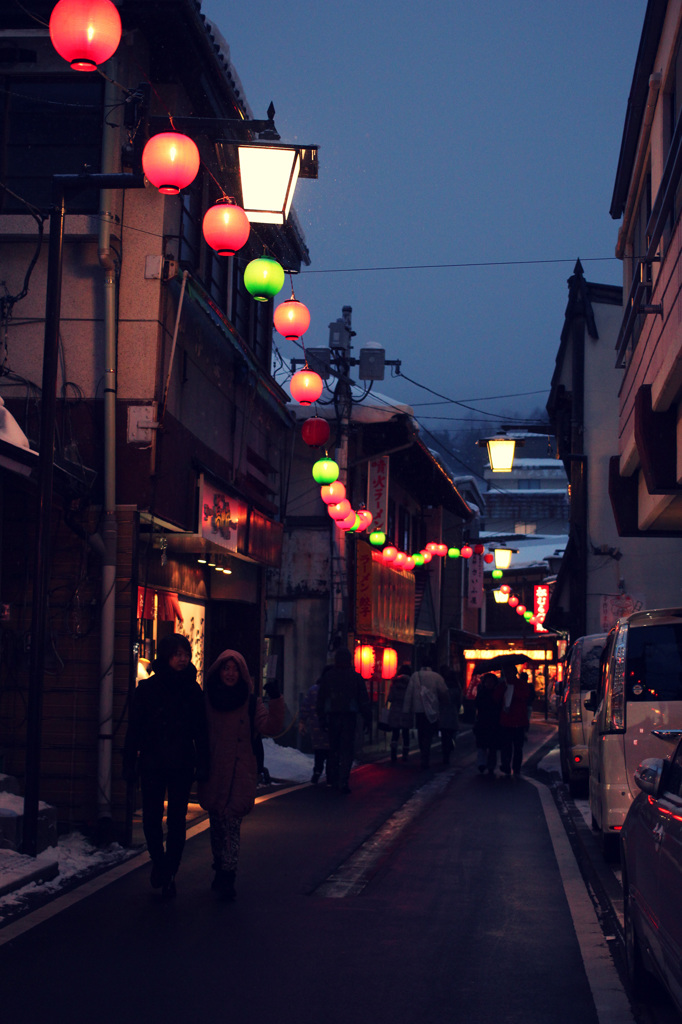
[97, 74, 120, 842]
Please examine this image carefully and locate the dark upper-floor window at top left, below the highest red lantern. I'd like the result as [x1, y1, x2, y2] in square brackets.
[0, 75, 103, 213]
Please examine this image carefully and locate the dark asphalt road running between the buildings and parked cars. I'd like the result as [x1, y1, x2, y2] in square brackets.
[0, 744, 632, 1024]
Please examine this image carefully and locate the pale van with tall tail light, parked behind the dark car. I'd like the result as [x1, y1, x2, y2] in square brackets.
[585, 608, 682, 859]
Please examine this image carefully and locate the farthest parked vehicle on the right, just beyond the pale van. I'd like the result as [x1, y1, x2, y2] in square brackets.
[557, 633, 607, 797]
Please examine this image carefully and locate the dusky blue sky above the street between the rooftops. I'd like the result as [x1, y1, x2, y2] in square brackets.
[202, 0, 646, 429]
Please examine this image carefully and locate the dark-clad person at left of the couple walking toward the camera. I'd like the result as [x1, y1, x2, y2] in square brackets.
[123, 633, 209, 897]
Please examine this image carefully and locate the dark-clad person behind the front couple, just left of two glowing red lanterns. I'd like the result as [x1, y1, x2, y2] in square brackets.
[317, 647, 371, 794]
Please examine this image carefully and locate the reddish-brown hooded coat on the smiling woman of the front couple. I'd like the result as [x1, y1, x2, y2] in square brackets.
[198, 650, 285, 818]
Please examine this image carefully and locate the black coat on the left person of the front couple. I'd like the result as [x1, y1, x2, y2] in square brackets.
[123, 665, 209, 781]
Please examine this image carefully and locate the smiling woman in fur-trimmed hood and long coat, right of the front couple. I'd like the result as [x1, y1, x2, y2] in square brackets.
[199, 650, 285, 901]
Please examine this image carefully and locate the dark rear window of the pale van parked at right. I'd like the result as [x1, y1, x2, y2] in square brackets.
[628, 624, 682, 701]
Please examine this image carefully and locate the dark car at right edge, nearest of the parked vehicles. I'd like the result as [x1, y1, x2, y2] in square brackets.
[621, 741, 682, 1014]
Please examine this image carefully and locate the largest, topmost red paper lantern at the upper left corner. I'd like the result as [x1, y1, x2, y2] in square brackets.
[49, 0, 122, 71]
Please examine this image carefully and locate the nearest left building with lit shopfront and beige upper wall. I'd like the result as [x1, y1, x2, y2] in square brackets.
[0, 0, 309, 839]
